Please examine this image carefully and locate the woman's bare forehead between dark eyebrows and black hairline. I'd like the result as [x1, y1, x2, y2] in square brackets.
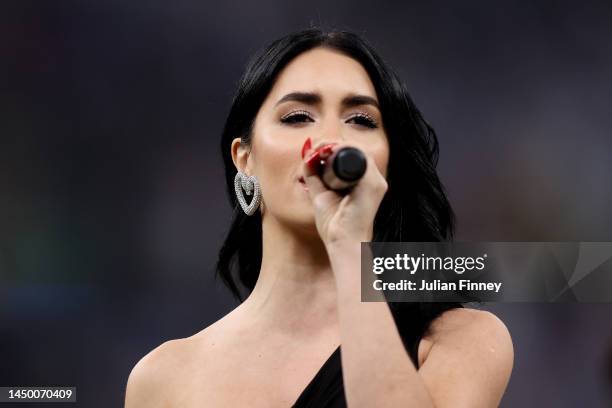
[270, 48, 376, 98]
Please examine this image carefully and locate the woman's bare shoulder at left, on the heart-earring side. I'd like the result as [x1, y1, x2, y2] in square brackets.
[125, 338, 193, 408]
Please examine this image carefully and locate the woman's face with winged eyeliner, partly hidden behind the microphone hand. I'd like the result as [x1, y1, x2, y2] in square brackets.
[232, 48, 389, 228]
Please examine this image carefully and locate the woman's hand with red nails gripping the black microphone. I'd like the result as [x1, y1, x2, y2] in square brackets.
[302, 143, 388, 246]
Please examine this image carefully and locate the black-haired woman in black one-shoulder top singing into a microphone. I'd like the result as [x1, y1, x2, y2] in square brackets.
[126, 29, 513, 408]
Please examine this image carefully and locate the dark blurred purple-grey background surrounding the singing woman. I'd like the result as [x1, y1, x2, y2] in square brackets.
[0, 0, 612, 408]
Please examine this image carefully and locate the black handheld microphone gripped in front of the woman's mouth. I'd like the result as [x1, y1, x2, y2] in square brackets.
[317, 146, 367, 191]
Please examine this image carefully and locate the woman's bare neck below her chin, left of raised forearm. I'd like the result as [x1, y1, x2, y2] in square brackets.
[242, 217, 337, 336]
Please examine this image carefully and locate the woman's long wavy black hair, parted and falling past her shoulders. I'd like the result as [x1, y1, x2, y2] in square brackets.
[216, 28, 461, 364]
